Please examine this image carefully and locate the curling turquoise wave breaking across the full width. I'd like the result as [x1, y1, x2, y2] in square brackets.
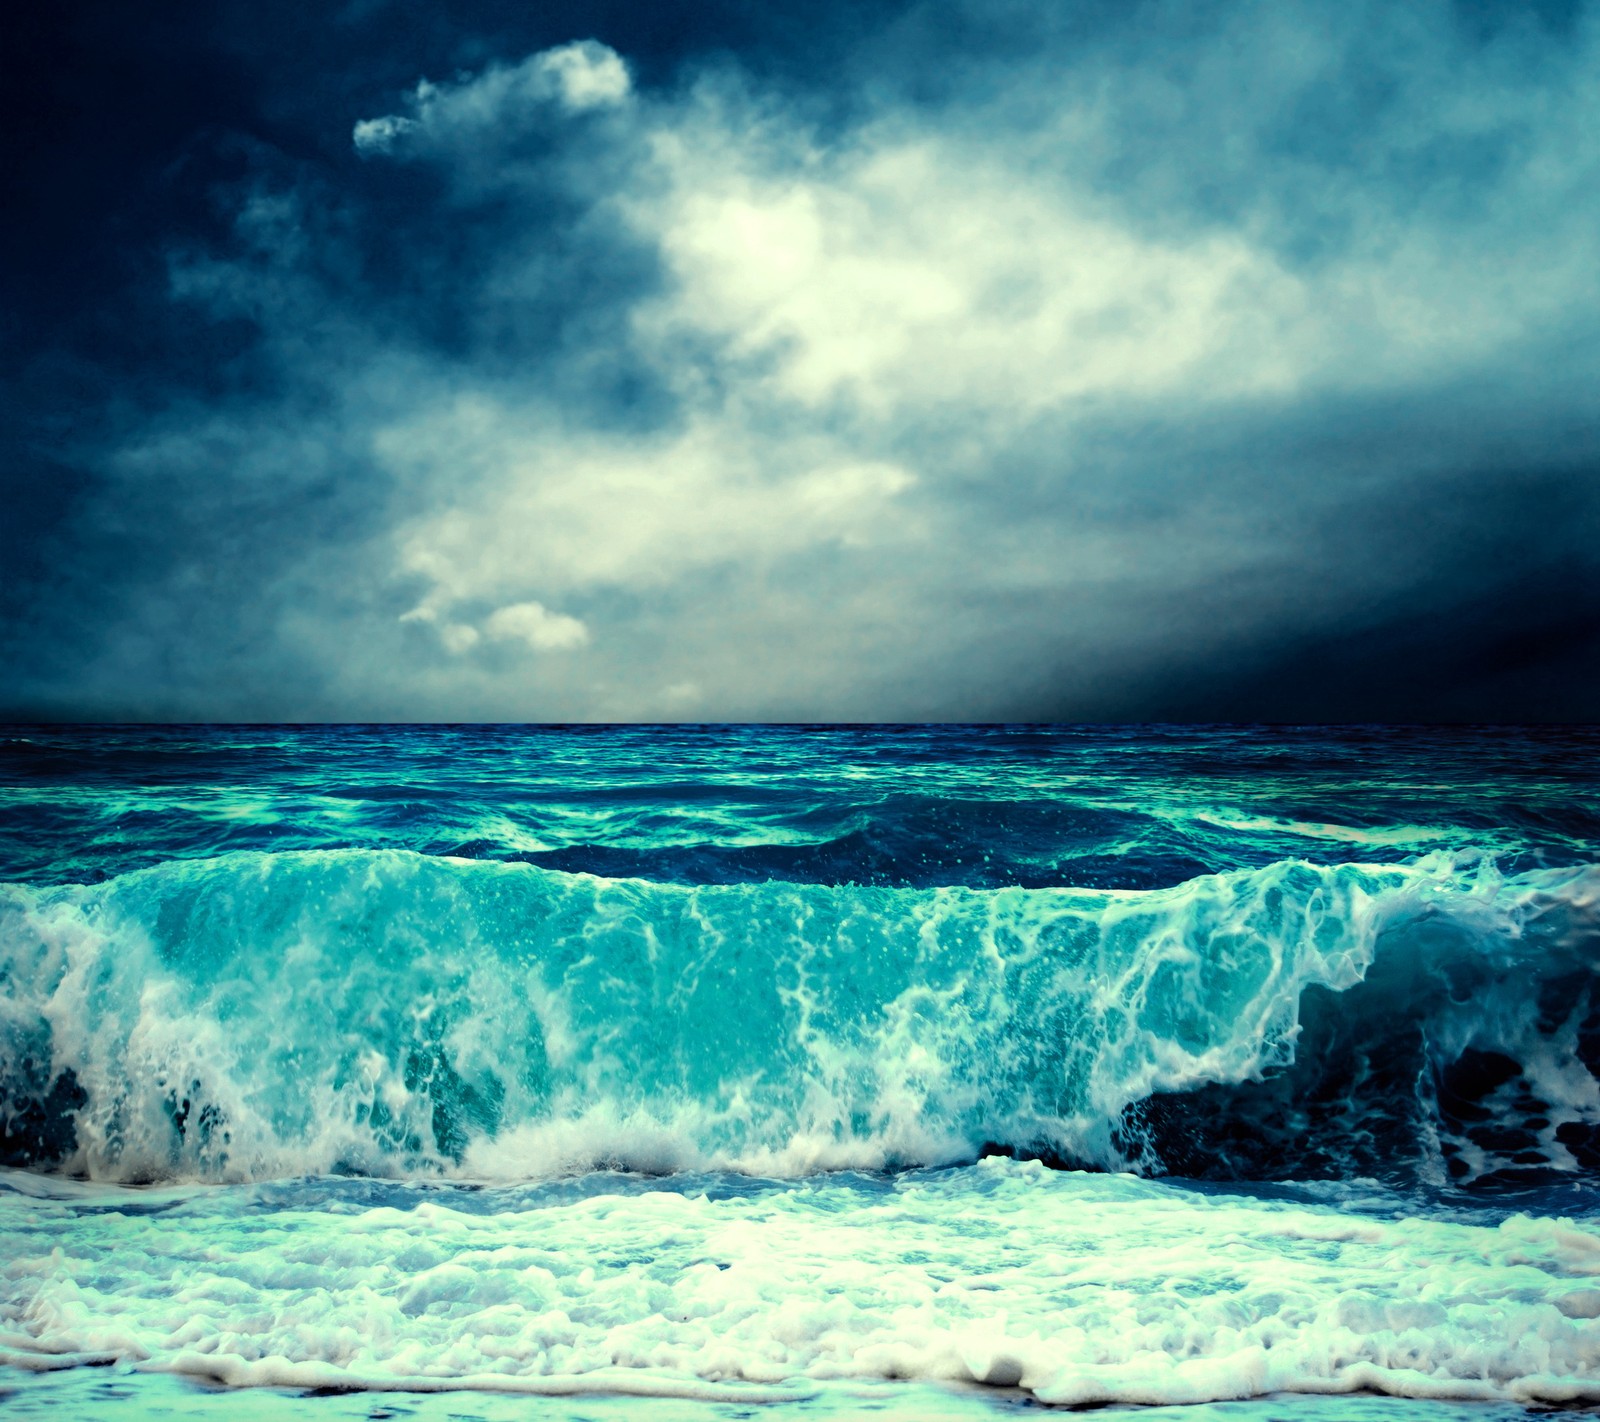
[0, 849, 1600, 1187]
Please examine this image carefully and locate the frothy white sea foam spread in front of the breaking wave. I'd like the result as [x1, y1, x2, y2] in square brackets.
[0, 1160, 1600, 1403]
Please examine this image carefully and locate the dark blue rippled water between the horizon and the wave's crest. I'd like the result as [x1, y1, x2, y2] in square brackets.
[0, 726, 1600, 888]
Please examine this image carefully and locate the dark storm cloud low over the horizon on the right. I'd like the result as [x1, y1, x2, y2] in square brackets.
[995, 387, 1600, 721]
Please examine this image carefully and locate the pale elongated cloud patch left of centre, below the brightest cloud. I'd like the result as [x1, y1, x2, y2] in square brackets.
[374, 395, 920, 617]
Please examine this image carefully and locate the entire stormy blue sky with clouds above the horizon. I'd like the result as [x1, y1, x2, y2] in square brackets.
[0, 0, 1600, 721]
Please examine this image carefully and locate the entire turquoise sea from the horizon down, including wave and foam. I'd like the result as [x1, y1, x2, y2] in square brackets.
[0, 726, 1600, 1422]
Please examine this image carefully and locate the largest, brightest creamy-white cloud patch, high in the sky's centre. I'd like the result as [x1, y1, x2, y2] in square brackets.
[627, 131, 1306, 419]
